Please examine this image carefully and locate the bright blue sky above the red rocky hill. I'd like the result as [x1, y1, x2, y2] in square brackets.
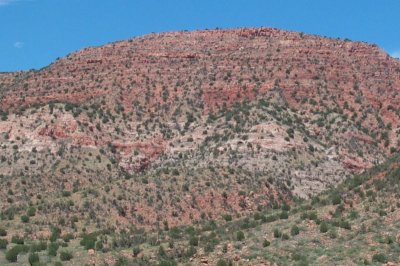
[0, 0, 400, 72]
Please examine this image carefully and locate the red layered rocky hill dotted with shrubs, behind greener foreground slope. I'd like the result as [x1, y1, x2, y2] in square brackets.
[0, 28, 400, 264]
